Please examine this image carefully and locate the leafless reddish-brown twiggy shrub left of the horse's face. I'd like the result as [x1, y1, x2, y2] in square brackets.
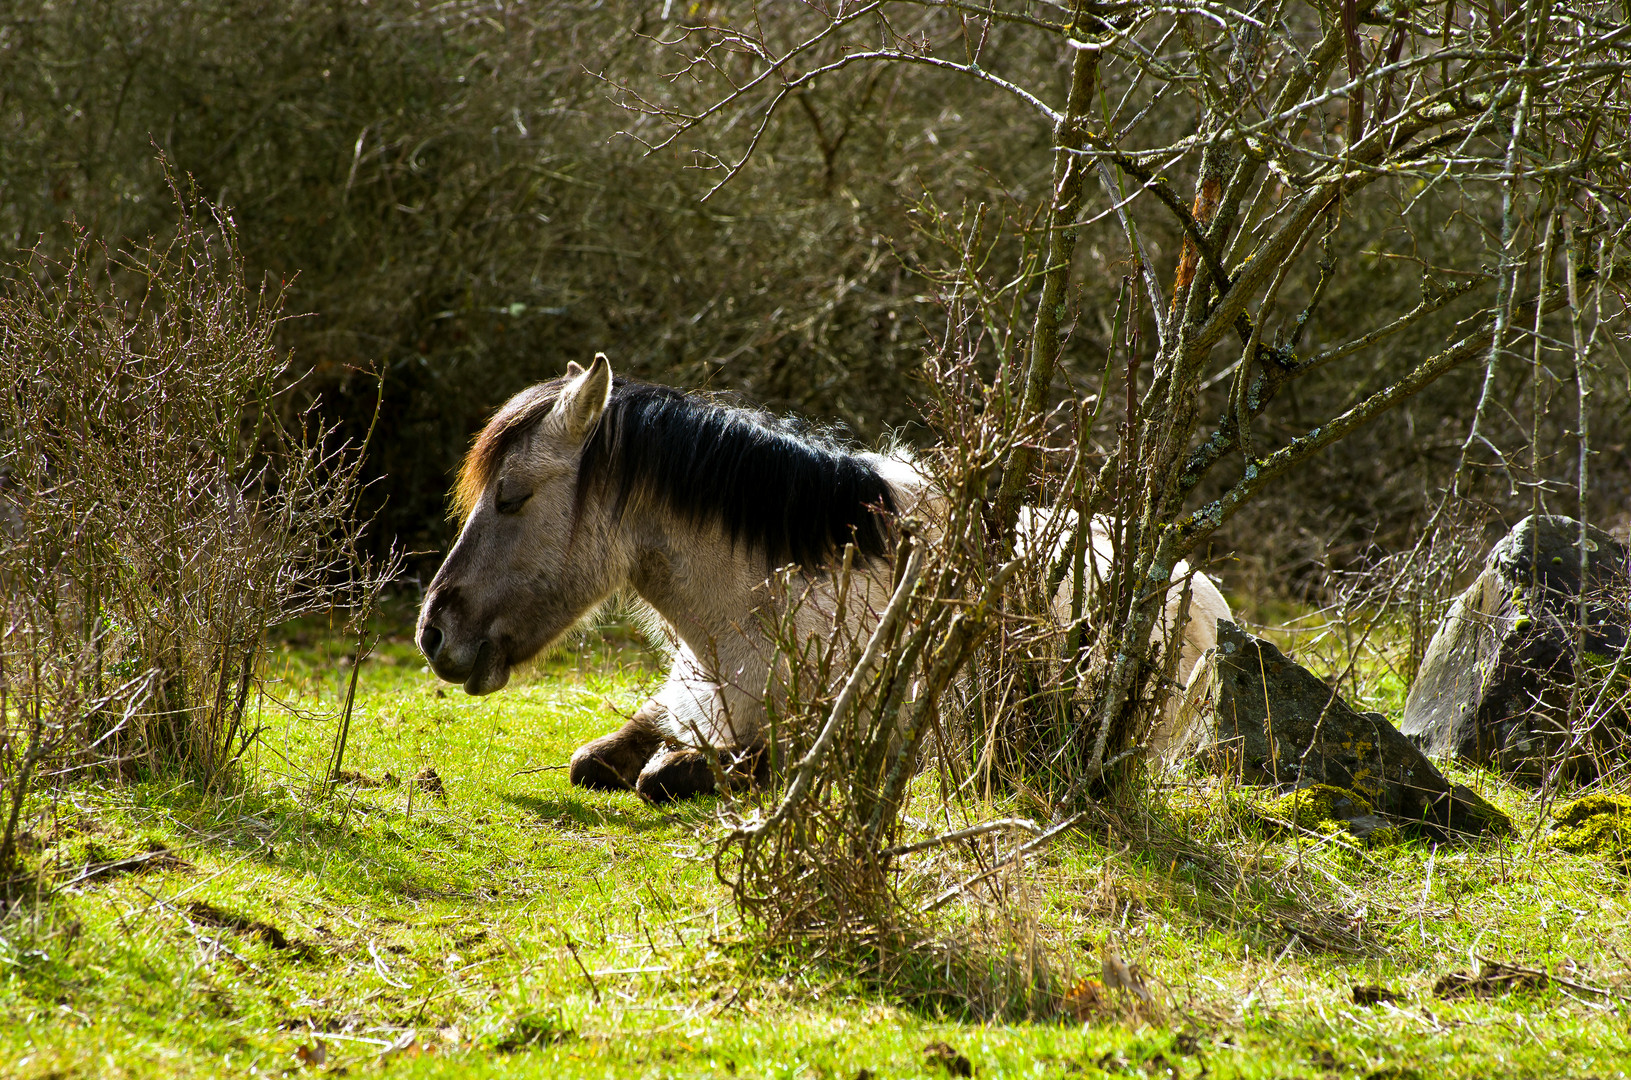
[0, 175, 395, 828]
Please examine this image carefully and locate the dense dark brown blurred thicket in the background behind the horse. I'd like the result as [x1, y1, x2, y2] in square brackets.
[0, 0, 1631, 587]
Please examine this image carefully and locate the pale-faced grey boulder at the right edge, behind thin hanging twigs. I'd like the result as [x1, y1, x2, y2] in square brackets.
[1399, 516, 1631, 783]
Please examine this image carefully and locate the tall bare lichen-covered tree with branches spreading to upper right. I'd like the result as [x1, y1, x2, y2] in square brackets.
[621, 0, 1631, 786]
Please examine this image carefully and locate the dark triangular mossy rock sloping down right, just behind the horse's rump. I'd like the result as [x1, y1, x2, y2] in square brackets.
[1179, 620, 1512, 837]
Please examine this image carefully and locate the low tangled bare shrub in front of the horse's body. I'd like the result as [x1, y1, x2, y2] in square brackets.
[716, 287, 1107, 1016]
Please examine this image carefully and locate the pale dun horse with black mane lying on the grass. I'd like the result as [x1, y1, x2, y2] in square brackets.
[416, 354, 1228, 803]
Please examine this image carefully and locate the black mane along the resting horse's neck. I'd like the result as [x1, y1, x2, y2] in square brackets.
[577, 378, 895, 571]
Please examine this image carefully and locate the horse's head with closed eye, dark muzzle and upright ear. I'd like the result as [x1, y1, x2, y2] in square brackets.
[418, 356, 618, 693]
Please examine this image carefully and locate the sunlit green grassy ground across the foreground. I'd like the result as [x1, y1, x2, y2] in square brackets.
[0, 613, 1631, 1080]
